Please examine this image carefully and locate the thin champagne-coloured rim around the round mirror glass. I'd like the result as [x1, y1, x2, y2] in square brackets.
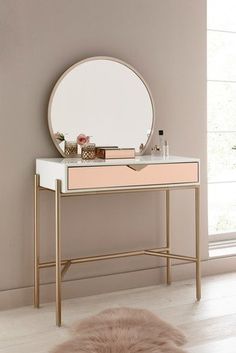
[48, 56, 156, 158]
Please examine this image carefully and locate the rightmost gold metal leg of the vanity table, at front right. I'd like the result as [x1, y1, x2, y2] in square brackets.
[195, 187, 201, 301]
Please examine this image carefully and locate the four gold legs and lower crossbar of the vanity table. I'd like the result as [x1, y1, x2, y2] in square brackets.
[34, 180, 201, 326]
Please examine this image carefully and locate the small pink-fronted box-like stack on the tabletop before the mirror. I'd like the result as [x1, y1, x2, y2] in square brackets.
[96, 146, 135, 159]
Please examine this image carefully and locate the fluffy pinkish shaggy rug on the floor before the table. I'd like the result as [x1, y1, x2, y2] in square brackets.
[52, 308, 186, 353]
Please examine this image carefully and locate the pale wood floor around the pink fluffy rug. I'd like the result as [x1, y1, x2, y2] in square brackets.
[0, 273, 236, 353]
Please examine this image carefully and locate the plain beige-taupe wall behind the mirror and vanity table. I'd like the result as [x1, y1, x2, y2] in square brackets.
[0, 0, 208, 302]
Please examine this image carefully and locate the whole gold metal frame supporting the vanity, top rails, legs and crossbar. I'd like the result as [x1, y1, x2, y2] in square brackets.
[34, 175, 201, 326]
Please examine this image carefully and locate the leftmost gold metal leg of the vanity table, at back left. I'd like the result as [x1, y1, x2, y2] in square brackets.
[34, 174, 40, 308]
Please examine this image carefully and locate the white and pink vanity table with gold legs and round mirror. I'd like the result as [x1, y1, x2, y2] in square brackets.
[34, 57, 201, 326]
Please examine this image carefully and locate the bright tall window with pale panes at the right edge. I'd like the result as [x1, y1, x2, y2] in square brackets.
[207, 0, 236, 240]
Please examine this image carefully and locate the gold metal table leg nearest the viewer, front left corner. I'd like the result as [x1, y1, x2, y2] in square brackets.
[55, 180, 61, 326]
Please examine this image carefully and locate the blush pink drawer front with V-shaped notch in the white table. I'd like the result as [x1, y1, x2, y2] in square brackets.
[68, 162, 199, 190]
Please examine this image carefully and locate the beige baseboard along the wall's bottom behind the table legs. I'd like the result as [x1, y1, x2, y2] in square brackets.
[0, 256, 236, 310]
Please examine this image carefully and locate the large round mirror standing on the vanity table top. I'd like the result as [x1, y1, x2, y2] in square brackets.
[48, 57, 154, 157]
